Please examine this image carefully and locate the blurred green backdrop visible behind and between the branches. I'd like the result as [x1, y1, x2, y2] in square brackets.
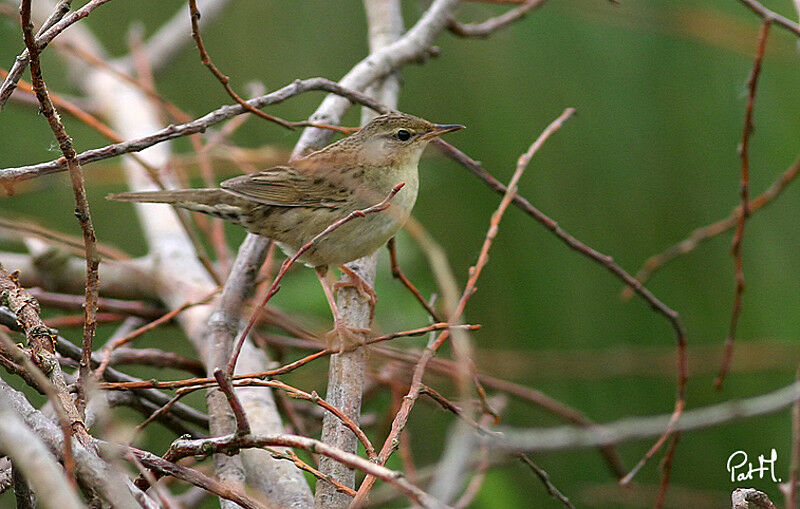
[0, 0, 800, 508]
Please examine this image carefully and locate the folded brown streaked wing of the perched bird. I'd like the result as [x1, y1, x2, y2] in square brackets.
[220, 166, 346, 208]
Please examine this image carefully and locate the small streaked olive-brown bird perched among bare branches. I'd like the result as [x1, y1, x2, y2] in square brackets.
[107, 112, 464, 351]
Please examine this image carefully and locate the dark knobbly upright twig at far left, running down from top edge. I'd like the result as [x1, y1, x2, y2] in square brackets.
[20, 0, 100, 413]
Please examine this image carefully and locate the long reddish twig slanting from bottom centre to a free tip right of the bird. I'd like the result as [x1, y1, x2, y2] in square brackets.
[353, 108, 575, 507]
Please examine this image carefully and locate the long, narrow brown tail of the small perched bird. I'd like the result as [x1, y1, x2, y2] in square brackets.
[106, 189, 248, 222]
